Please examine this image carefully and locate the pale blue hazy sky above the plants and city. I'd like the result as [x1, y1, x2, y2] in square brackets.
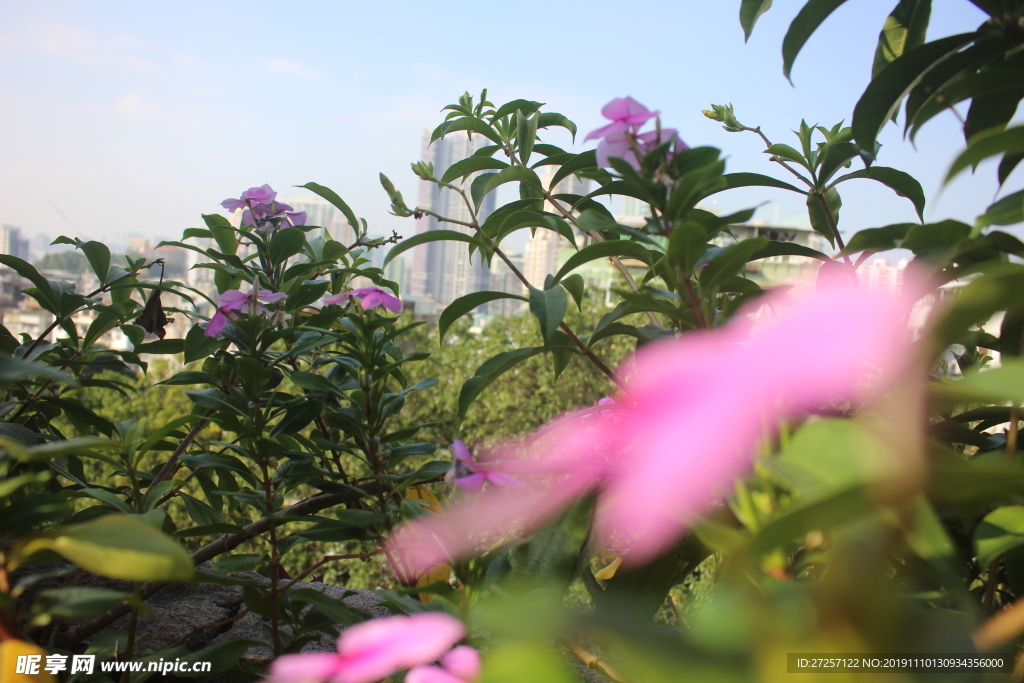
[0, 0, 1014, 250]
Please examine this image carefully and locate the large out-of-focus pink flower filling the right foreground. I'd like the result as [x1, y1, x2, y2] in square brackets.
[389, 274, 929, 575]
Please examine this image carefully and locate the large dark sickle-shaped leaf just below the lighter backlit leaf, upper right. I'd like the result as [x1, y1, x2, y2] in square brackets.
[852, 33, 975, 155]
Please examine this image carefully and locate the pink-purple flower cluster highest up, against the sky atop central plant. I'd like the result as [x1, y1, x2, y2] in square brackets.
[584, 97, 689, 170]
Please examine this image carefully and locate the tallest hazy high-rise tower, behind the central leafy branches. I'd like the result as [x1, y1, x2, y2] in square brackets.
[410, 130, 497, 306]
